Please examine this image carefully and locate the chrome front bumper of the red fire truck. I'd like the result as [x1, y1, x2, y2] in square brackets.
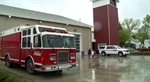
[35, 63, 79, 72]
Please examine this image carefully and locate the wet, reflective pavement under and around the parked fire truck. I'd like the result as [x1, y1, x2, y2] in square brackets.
[0, 55, 150, 82]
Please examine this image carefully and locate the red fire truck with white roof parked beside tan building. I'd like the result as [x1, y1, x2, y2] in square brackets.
[0, 25, 78, 74]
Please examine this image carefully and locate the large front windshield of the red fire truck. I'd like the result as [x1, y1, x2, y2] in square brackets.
[42, 34, 75, 48]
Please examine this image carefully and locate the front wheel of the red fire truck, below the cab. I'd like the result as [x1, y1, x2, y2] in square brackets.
[26, 59, 36, 75]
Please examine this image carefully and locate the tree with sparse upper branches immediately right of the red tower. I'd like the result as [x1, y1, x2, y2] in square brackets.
[119, 18, 140, 46]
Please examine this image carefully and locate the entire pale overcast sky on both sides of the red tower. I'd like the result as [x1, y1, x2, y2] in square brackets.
[0, 0, 150, 25]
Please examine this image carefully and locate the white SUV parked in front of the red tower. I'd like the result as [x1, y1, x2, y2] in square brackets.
[98, 45, 130, 57]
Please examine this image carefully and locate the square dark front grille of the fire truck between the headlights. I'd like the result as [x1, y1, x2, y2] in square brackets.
[58, 52, 68, 63]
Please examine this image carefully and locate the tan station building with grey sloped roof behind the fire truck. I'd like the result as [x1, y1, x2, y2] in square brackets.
[0, 5, 92, 52]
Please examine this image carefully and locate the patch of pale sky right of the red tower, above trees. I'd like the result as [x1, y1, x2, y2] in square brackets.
[118, 0, 150, 21]
